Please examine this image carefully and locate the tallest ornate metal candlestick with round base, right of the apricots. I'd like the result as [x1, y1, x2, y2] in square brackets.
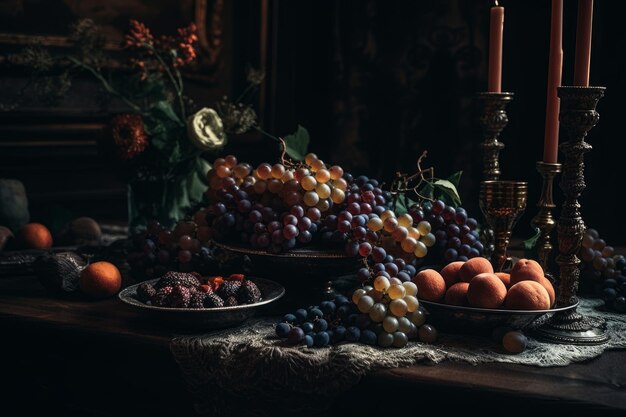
[536, 87, 608, 345]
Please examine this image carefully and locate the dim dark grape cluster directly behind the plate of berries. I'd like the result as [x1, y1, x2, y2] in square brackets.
[127, 221, 217, 280]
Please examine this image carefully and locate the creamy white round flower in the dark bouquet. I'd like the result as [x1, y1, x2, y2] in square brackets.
[187, 107, 226, 151]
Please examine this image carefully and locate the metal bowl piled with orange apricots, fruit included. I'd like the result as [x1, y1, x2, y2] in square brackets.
[413, 257, 576, 334]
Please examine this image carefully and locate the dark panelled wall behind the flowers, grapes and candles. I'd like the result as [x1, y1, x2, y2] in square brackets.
[0, 0, 626, 246]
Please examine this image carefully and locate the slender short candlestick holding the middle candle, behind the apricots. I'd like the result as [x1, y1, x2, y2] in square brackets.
[531, 161, 561, 274]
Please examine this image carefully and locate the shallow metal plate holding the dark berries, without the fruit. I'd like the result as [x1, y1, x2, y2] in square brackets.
[118, 277, 285, 330]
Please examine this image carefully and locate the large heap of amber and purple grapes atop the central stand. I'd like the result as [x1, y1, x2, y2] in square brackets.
[206, 153, 366, 253]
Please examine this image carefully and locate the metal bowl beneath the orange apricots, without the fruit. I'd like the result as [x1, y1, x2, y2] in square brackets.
[419, 299, 578, 335]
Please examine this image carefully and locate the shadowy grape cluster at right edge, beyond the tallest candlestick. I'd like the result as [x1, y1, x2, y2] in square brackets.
[578, 228, 626, 313]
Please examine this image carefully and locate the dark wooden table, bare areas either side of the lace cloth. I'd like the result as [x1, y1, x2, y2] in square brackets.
[0, 276, 626, 416]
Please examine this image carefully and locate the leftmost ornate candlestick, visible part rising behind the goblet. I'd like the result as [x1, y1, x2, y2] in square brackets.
[478, 92, 513, 181]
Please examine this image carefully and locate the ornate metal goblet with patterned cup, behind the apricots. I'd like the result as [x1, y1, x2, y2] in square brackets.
[479, 181, 528, 271]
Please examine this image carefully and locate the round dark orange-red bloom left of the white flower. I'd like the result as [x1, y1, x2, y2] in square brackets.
[109, 113, 148, 160]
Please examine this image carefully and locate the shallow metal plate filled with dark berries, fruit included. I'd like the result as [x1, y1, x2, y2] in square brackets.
[118, 271, 285, 330]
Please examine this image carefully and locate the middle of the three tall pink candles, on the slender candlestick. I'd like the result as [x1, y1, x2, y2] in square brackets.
[543, 0, 563, 163]
